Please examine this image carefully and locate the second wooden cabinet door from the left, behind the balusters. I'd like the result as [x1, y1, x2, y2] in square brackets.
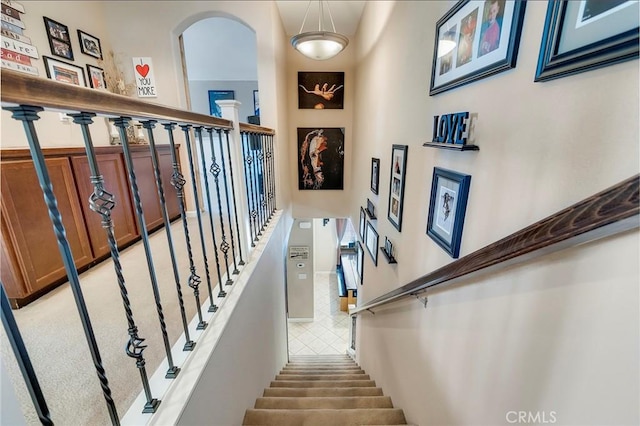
[71, 154, 138, 257]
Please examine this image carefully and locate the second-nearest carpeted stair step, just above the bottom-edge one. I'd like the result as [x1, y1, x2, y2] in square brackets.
[253, 396, 393, 410]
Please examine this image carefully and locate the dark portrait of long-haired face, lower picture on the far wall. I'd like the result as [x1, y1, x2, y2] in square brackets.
[298, 127, 344, 189]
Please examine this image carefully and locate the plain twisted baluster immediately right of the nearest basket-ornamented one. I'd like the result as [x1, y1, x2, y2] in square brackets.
[112, 117, 180, 379]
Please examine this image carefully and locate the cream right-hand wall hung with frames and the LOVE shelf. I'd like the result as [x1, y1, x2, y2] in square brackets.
[352, 1, 640, 425]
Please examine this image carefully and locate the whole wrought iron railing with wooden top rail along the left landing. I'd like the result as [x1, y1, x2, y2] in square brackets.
[0, 70, 276, 424]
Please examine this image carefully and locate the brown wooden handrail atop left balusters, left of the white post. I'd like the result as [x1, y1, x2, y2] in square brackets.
[0, 69, 233, 129]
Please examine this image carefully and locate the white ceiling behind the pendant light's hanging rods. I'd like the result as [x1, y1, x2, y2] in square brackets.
[276, 0, 366, 36]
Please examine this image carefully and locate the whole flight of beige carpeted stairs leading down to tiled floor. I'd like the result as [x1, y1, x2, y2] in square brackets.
[243, 355, 407, 426]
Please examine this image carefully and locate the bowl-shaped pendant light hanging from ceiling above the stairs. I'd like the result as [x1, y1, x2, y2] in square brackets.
[291, 0, 349, 61]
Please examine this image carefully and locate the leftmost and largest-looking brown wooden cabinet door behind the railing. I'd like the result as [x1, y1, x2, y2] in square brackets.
[0, 158, 93, 298]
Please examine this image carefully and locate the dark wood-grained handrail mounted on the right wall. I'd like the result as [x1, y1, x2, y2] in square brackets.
[349, 175, 640, 315]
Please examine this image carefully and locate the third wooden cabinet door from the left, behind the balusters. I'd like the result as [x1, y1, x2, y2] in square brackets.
[131, 147, 164, 230]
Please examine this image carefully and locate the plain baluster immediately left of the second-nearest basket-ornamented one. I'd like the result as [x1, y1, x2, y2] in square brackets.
[141, 120, 196, 351]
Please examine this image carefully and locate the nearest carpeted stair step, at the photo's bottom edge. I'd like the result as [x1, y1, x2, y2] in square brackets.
[243, 408, 406, 426]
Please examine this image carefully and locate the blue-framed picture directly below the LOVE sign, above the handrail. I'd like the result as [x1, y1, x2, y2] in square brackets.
[427, 167, 471, 259]
